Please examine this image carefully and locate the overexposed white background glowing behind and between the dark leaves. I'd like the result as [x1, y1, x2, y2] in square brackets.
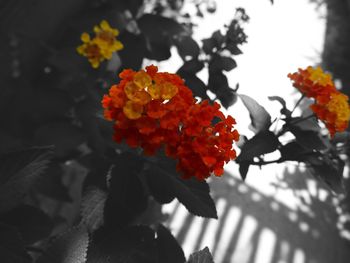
[152, 0, 325, 208]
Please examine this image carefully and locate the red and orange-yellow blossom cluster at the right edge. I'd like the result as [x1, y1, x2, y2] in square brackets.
[288, 66, 350, 137]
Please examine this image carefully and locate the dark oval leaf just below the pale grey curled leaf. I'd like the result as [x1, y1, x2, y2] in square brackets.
[236, 131, 280, 163]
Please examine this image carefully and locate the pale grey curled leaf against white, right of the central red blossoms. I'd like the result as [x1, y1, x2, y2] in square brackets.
[239, 94, 271, 132]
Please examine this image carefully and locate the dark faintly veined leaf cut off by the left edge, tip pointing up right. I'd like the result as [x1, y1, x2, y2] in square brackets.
[0, 147, 53, 212]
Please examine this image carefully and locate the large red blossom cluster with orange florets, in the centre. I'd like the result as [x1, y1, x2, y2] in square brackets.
[102, 65, 239, 180]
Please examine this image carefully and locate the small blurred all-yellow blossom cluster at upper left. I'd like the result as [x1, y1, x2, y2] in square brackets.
[77, 20, 123, 68]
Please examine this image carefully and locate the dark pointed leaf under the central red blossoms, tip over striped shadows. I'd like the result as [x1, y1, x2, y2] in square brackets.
[147, 160, 217, 218]
